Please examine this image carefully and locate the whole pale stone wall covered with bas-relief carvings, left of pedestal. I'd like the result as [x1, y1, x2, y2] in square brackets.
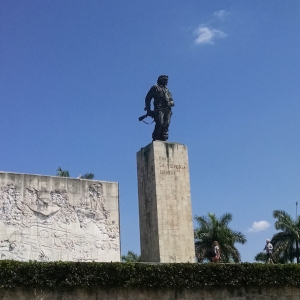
[0, 172, 120, 262]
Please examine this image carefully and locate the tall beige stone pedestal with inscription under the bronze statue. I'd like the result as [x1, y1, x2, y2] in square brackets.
[137, 141, 195, 263]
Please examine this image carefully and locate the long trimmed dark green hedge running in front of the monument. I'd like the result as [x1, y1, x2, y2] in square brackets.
[0, 260, 300, 288]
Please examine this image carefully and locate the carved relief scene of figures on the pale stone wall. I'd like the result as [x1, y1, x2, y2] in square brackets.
[0, 183, 119, 261]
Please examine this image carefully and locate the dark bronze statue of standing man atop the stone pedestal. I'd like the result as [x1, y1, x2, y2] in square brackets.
[145, 75, 174, 141]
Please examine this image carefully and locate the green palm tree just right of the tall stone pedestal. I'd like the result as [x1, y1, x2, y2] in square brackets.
[194, 213, 247, 262]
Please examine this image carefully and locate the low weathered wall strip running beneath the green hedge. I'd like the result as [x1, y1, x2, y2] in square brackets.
[0, 286, 300, 300]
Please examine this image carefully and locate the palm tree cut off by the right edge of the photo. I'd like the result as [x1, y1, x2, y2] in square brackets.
[271, 210, 300, 263]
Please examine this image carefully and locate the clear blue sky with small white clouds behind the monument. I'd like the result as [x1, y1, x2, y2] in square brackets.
[0, 0, 300, 262]
